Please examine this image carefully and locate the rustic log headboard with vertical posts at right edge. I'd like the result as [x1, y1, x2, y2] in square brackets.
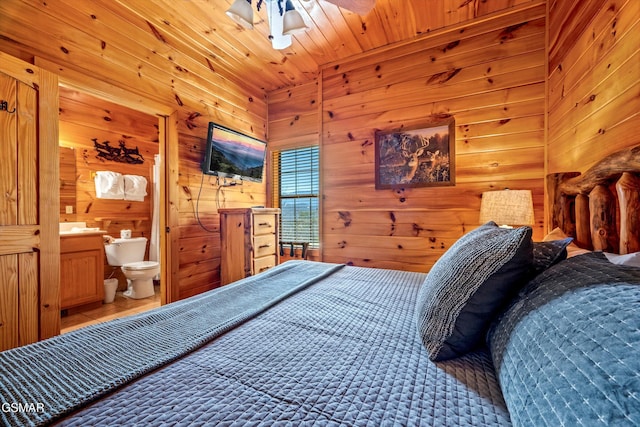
[546, 146, 640, 254]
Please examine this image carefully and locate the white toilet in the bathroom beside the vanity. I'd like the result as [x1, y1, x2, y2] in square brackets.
[104, 237, 160, 299]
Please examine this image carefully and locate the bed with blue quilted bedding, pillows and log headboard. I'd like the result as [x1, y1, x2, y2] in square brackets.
[0, 146, 640, 426]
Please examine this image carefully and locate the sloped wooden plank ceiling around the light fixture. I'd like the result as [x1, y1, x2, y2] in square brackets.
[0, 0, 531, 92]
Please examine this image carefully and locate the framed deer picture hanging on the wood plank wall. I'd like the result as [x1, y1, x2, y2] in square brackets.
[375, 117, 455, 189]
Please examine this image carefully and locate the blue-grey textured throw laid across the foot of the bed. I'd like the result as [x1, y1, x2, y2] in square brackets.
[0, 262, 343, 426]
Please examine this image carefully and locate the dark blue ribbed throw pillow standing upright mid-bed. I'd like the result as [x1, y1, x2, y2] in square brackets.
[416, 222, 533, 361]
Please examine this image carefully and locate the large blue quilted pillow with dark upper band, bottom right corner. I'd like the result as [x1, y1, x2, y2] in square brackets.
[489, 253, 640, 426]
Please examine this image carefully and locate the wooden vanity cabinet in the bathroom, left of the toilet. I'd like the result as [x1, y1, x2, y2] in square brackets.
[60, 234, 105, 310]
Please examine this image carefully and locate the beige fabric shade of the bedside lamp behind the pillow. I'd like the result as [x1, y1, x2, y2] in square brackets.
[480, 190, 535, 226]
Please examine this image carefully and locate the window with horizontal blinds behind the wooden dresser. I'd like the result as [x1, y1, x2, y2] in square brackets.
[273, 147, 320, 248]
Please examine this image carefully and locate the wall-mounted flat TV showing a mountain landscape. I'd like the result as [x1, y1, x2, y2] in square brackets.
[202, 122, 267, 182]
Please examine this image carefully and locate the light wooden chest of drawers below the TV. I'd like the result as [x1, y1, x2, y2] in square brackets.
[218, 208, 280, 285]
